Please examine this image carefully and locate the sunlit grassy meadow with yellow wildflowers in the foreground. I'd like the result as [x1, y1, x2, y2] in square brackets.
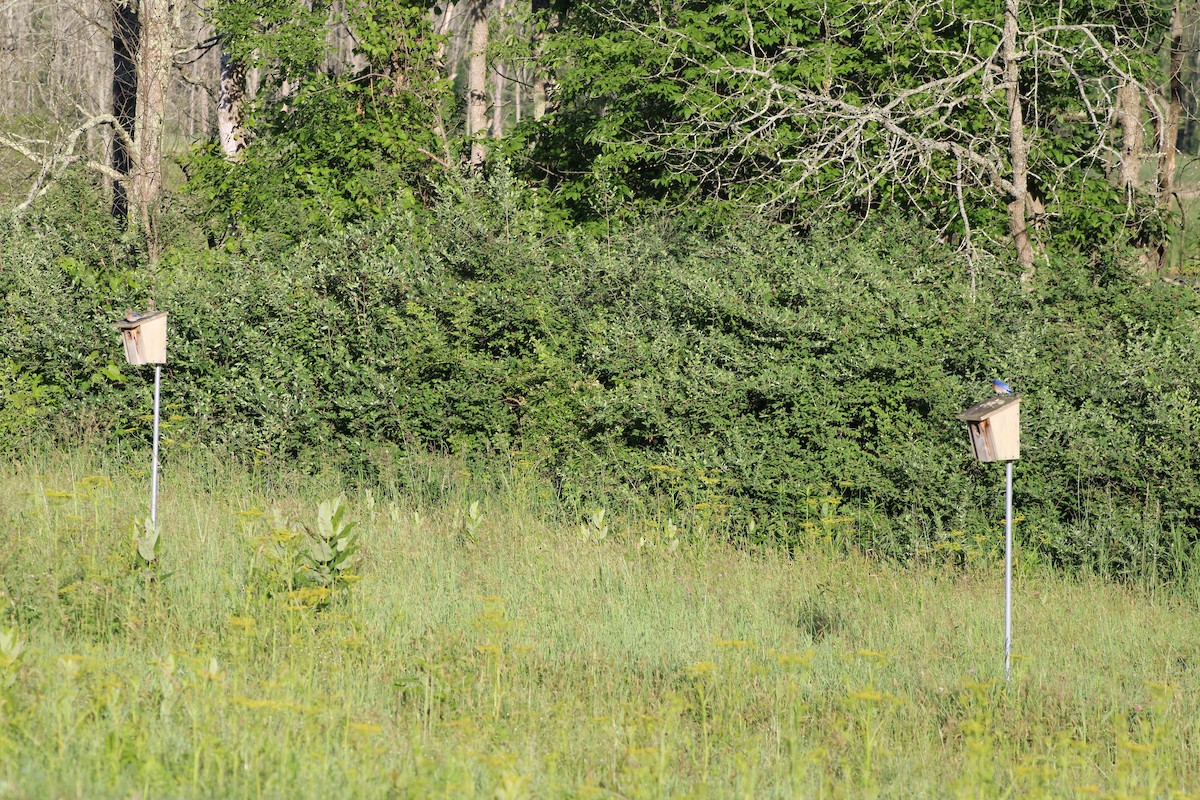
[0, 456, 1200, 799]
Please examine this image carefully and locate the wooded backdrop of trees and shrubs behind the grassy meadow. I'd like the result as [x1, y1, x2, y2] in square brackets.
[0, 0, 1200, 583]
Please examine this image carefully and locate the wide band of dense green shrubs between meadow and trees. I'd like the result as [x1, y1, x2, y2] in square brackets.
[0, 175, 1200, 575]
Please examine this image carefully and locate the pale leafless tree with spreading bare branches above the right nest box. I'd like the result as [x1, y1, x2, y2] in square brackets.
[576, 0, 1166, 266]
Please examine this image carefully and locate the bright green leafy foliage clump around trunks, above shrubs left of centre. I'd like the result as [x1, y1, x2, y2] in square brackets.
[185, 0, 449, 240]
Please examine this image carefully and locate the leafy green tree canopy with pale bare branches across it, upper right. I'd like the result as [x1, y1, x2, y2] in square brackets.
[544, 0, 1165, 275]
